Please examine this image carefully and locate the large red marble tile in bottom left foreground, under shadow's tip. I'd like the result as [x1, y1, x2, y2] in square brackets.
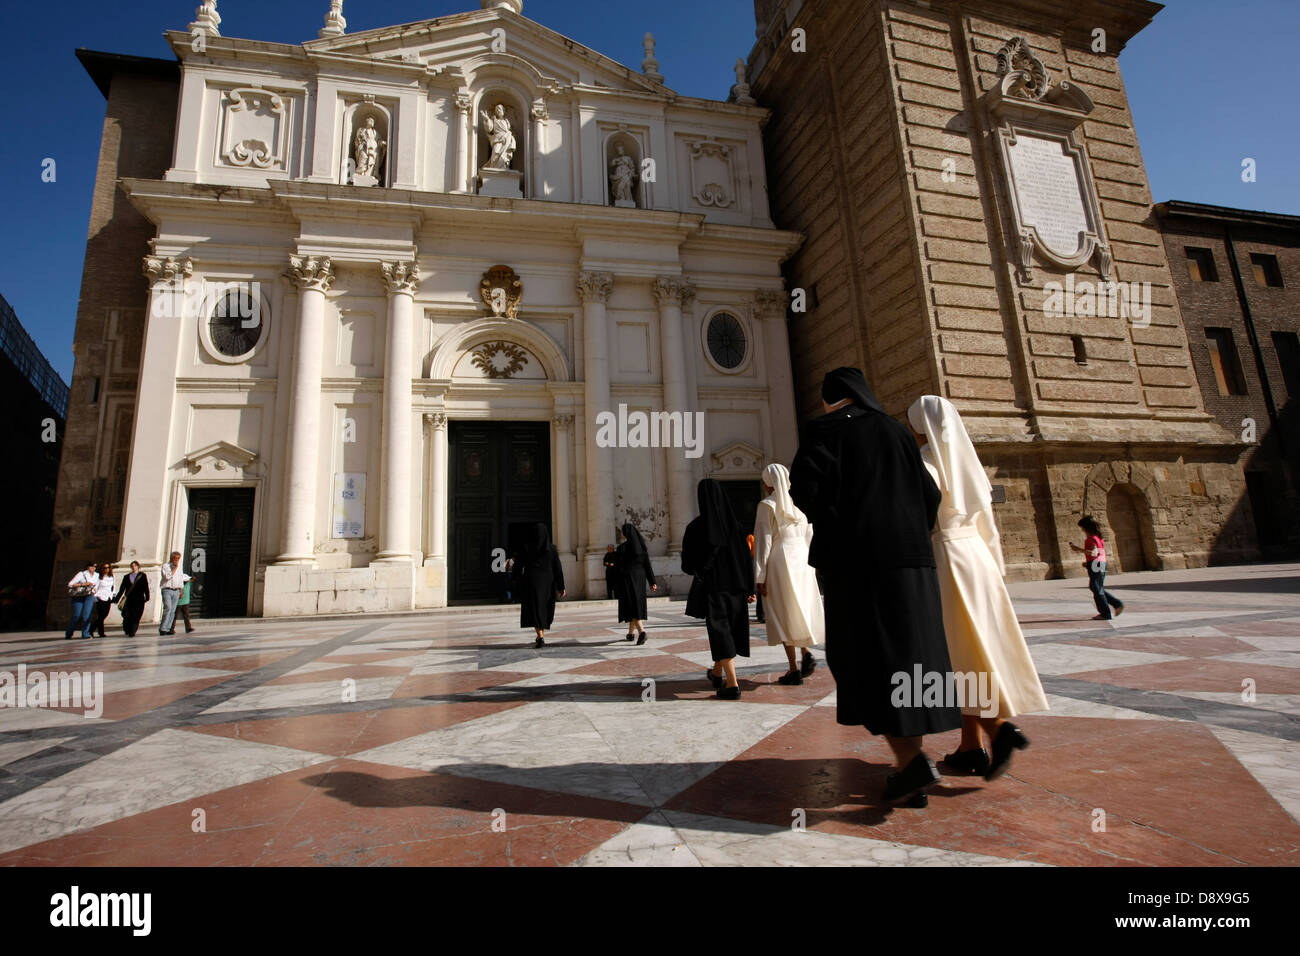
[0, 760, 646, 866]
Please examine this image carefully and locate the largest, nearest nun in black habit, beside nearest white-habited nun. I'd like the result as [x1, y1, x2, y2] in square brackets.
[790, 368, 961, 805]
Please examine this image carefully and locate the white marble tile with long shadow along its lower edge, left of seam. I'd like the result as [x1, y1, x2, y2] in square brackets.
[352, 701, 650, 812]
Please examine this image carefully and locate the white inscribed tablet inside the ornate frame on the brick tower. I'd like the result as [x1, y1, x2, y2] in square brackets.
[1006, 130, 1092, 259]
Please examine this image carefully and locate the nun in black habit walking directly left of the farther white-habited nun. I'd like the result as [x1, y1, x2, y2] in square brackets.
[681, 479, 754, 700]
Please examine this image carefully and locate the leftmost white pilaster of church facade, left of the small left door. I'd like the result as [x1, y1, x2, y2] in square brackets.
[118, 255, 191, 574]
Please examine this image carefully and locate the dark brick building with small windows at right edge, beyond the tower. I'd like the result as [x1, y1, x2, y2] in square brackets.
[1156, 200, 1300, 557]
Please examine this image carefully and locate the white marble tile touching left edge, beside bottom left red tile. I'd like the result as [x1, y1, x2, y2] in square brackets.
[0, 730, 335, 853]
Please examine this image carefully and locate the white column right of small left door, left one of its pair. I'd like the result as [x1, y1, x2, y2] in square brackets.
[276, 256, 334, 564]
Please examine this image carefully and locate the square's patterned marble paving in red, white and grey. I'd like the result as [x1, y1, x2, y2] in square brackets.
[0, 564, 1300, 866]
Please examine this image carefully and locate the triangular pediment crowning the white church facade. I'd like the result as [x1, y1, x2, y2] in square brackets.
[303, 8, 675, 96]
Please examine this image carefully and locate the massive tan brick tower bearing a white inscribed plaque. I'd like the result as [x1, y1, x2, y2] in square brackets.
[748, 0, 1256, 579]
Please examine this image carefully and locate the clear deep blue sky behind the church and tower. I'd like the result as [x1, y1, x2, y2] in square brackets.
[0, 0, 1300, 381]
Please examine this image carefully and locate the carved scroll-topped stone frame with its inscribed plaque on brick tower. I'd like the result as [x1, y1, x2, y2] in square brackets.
[984, 36, 1112, 282]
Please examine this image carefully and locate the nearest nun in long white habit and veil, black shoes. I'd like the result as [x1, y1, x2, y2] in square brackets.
[907, 395, 1048, 780]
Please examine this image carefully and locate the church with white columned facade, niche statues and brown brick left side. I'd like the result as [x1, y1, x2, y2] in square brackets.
[48, 0, 800, 615]
